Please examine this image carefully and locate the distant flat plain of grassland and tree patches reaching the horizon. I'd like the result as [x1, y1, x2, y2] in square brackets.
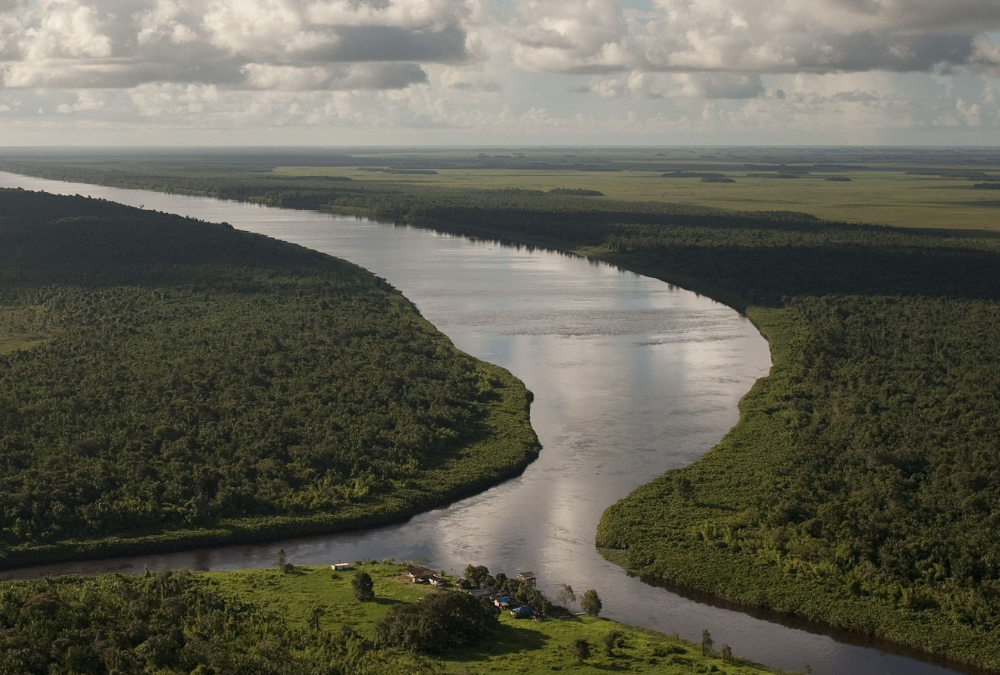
[7, 148, 1000, 230]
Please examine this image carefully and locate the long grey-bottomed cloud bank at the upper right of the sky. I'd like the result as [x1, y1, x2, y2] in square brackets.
[514, 0, 1000, 74]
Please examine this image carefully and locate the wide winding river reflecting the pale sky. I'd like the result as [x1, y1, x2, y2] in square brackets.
[0, 173, 976, 675]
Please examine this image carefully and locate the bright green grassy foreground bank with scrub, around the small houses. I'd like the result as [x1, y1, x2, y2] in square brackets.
[0, 564, 792, 675]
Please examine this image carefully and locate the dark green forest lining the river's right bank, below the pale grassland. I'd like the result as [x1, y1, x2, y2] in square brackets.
[6, 162, 1000, 669]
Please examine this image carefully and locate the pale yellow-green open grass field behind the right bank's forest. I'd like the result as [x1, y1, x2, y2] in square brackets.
[274, 167, 1000, 230]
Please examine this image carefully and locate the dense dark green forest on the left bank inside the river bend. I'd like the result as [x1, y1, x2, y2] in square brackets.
[0, 190, 538, 565]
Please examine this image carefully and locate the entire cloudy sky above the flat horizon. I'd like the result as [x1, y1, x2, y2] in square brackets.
[0, 0, 1000, 145]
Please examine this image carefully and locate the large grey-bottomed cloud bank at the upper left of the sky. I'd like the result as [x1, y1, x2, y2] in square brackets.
[0, 0, 470, 91]
